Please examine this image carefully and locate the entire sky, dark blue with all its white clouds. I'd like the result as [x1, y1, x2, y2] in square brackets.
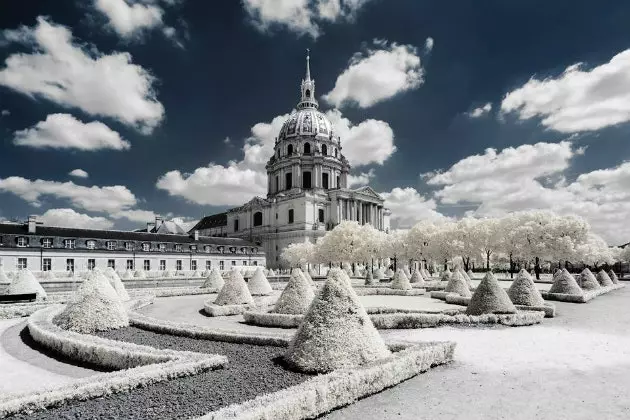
[0, 0, 630, 244]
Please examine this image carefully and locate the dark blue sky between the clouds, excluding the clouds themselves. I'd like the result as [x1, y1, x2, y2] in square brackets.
[0, 0, 630, 243]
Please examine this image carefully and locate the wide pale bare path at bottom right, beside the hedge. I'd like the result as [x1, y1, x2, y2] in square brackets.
[324, 287, 630, 420]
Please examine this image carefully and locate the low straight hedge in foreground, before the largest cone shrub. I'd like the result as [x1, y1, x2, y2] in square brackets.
[199, 342, 455, 420]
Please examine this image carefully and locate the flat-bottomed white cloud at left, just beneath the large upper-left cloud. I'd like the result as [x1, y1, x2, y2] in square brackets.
[13, 114, 131, 151]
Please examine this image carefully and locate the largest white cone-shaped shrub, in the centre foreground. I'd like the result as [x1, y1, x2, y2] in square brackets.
[284, 269, 391, 373]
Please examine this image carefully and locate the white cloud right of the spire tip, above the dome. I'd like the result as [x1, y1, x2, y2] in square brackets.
[323, 40, 424, 108]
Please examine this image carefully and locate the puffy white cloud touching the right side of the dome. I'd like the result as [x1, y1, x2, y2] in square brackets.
[326, 109, 396, 166]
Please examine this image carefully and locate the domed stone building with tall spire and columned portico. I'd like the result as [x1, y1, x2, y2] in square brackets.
[191, 56, 391, 268]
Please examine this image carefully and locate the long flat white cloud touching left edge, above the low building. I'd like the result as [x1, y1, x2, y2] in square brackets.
[0, 176, 137, 212]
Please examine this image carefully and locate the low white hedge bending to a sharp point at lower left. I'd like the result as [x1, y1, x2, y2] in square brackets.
[0, 306, 228, 417]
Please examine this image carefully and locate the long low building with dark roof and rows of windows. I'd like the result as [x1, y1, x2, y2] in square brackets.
[0, 216, 265, 272]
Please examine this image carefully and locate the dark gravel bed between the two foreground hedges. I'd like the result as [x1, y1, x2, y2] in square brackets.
[15, 327, 310, 420]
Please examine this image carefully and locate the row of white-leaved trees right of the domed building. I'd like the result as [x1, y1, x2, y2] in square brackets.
[282, 210, 630, 275]
